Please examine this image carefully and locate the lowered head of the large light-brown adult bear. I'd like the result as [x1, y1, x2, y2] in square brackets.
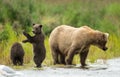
[94, 32, 109, 51]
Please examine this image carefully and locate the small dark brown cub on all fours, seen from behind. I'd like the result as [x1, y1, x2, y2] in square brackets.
[10, 42, 24, 65]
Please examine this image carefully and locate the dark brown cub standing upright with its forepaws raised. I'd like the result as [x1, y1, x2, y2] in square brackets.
[23, 24, 46, 67]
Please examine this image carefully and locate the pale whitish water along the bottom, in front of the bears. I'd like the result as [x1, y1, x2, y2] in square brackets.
[0, 58, 120, 77]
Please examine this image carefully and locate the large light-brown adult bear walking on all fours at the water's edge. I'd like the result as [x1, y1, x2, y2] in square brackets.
[49, 25, 109, 66]
